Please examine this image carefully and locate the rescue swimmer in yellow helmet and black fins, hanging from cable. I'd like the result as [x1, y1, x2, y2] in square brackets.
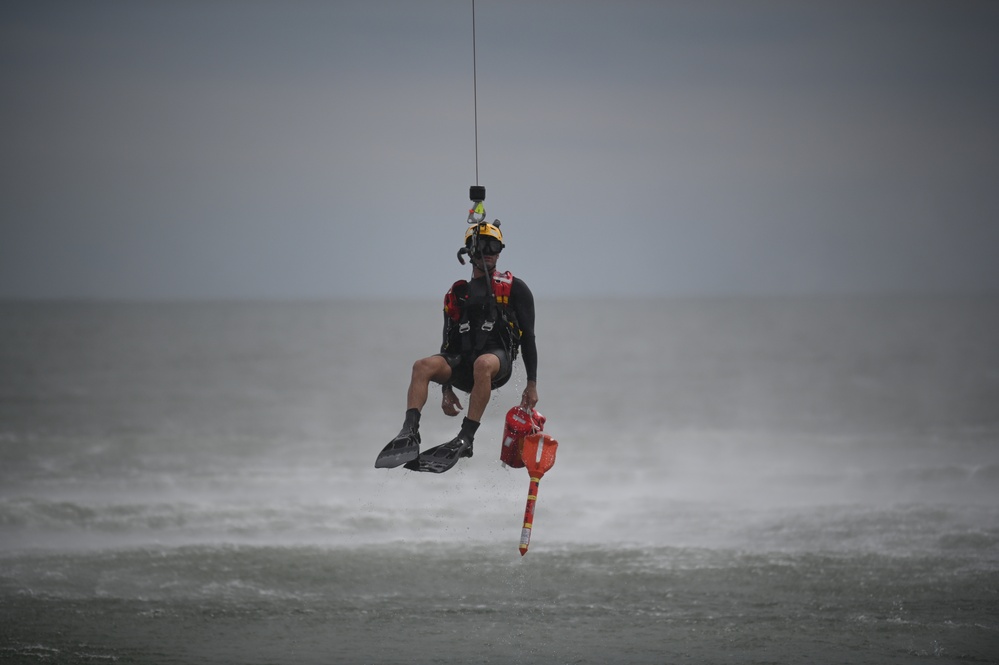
[375, 220, 538, 473]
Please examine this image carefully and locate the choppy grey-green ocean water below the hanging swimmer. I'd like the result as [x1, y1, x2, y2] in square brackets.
[0, 297, 999, 664]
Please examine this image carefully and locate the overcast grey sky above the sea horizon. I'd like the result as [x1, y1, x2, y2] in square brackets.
[0, 0, 999, 298]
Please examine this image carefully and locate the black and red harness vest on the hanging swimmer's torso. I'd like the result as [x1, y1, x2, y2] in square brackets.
[441, 270, 521, 361]
